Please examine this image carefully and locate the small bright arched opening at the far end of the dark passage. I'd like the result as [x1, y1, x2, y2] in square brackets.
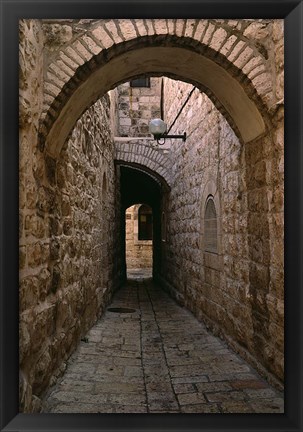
[125, 203, 153, 279]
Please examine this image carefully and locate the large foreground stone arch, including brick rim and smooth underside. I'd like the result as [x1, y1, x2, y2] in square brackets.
[40, 20, 275, 156]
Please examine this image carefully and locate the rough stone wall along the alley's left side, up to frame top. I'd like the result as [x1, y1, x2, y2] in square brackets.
[19, 22, 118, 412]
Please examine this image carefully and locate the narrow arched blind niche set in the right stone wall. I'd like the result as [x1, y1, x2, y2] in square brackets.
[204, 195, 218, 253]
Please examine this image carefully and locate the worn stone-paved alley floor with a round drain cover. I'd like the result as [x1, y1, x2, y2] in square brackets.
[43, 273, 284, 413]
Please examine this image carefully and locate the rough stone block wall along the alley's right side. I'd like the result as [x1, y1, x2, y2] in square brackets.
[160, 69, 284, 385]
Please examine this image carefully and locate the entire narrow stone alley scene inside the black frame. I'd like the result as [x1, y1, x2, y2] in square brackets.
[16, 20, 288, 414]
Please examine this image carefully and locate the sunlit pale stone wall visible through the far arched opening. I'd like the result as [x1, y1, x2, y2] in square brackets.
[125, 204, 153, 269]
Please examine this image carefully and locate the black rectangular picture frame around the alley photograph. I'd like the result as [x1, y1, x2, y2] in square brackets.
[0, 0, 303, 432]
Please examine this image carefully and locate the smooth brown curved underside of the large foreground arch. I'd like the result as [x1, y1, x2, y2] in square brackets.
[45, 46, 265, 157]
